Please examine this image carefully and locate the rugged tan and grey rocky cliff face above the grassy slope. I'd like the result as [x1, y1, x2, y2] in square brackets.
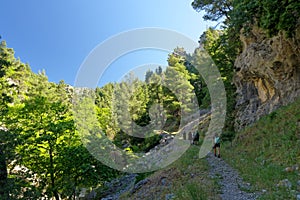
[234, 26, 300, 130]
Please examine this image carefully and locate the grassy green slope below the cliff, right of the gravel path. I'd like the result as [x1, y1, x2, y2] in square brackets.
[222, 99, 300, 199]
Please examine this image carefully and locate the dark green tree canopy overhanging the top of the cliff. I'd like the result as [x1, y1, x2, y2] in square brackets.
[192, 0, 300, 36]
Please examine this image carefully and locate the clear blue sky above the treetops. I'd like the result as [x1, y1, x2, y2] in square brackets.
[0, 0, 216, 85]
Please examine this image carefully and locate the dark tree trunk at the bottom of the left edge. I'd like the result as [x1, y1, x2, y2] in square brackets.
[0, 147, 9, 200]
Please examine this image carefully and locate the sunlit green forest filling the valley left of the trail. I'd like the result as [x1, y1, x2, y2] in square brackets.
[0, 41, 216, 199]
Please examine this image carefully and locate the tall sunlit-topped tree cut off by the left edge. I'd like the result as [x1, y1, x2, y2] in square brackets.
[0, 41, 33, 199]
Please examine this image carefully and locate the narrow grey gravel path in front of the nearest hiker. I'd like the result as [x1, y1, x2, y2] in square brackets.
[206, 153, 258, 200]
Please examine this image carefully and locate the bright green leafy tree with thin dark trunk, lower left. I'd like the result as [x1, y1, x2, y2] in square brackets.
[10, 74, 74, 199]
